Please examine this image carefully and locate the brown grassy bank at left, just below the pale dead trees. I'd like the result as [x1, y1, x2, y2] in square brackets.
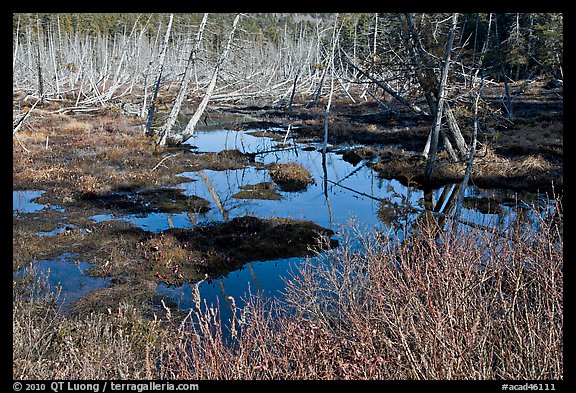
[12, 110, 253, 212]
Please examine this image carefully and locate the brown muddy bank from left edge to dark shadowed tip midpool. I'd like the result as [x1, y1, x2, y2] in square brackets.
[13, 213, 337, 316]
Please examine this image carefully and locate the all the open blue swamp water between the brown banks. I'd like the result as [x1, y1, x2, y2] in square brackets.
[13, 125, 548, 321]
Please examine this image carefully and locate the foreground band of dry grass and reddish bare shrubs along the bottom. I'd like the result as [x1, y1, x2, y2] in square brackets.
[13, 198, 564, 380]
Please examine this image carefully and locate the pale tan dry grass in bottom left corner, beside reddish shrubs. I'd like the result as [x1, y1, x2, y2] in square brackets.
[13, 274, 167, 379]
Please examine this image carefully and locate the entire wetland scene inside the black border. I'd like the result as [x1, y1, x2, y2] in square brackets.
[12, 13, 564, 380]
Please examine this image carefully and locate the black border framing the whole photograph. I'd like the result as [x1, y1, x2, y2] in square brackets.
[3, 6, 574, 392]
